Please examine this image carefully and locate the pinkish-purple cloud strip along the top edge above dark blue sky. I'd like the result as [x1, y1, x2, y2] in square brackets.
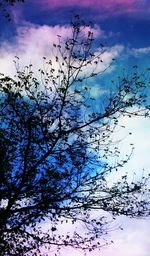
[38, 0, 146, 13]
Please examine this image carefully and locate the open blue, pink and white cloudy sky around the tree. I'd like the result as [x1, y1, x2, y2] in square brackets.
[0, 0, 150, 256]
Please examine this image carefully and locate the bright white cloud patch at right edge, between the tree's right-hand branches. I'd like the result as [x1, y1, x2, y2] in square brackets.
[108, 113, 150, 181]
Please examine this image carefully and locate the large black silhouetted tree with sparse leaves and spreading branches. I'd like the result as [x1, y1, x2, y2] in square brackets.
[0, 16, 149, 256]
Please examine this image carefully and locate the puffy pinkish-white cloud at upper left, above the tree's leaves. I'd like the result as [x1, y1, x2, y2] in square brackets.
[0, 23, 71, 75]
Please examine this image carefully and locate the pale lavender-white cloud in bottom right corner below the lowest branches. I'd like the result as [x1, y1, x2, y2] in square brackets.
[102, 217, 150, 256]
